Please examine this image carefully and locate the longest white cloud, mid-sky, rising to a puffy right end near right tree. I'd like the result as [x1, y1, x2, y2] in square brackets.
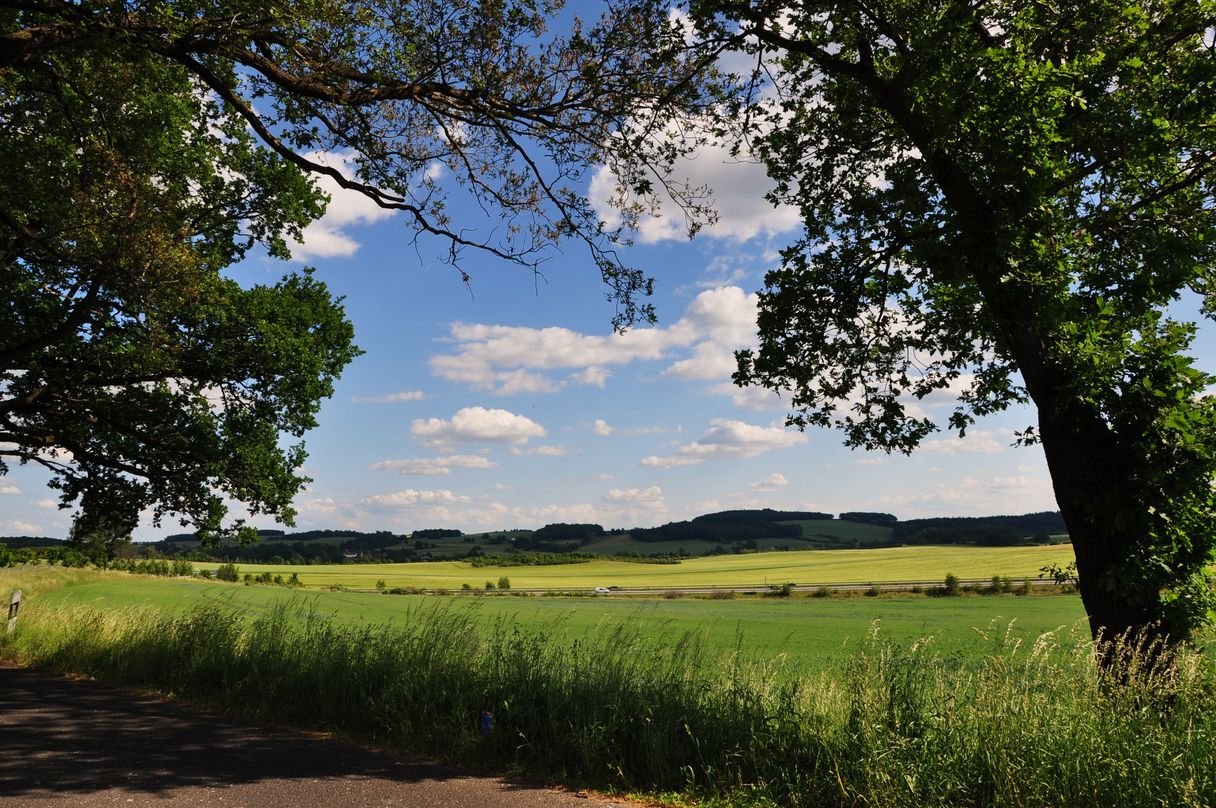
[430, 286, 758, 395]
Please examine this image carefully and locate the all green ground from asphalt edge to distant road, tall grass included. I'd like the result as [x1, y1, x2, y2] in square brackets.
[0, 569, 1216, 808]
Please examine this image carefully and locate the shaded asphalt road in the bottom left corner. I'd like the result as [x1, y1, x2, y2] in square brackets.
[0, 666, 614, 808]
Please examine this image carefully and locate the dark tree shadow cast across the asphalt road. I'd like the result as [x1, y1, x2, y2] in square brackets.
[0, 666, 466, 797]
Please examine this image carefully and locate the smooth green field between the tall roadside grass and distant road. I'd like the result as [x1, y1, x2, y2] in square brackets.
[29, 573, 1083, 670]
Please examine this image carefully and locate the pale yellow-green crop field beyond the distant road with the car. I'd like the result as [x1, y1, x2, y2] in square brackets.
[197, 544, 1073, 591]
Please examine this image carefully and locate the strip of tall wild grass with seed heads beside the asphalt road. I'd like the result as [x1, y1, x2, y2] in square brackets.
[0, 586, 1216, 808]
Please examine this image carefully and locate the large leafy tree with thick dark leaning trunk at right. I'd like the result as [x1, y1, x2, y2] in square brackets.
[692, 0, 1216, 639]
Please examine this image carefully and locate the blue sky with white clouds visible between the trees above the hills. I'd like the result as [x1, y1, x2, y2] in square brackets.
[0, 12, 1216, 540]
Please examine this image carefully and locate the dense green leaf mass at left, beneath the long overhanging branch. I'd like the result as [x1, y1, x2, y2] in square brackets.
[0, 25, 358, 540]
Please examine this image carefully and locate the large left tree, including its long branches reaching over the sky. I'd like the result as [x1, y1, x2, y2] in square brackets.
[0, 0, 711, 542]
